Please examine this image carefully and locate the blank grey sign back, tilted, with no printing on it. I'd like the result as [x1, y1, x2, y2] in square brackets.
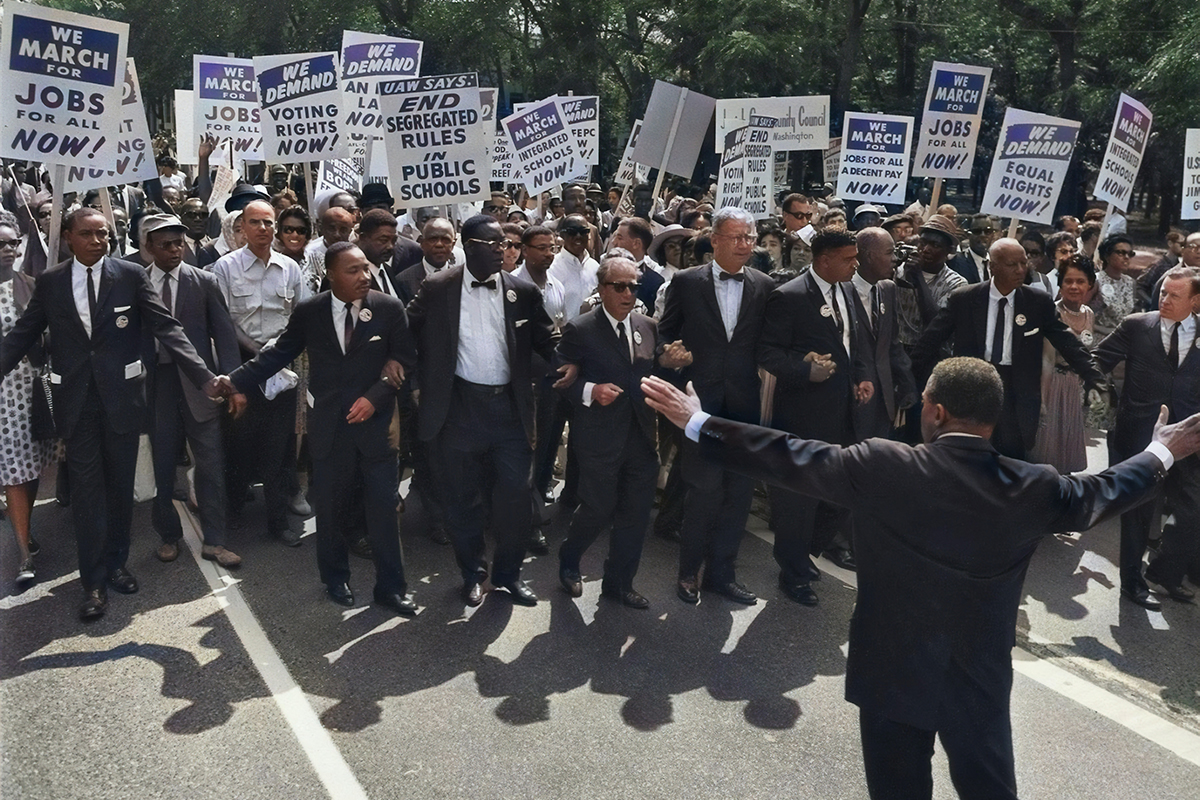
[634, 80, 716, 179]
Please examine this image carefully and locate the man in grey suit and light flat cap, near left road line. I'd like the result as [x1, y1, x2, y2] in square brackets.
[142, 213, 246, 567]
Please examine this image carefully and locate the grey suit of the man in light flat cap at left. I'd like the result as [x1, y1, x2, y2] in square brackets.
[142, 264, 241, 547]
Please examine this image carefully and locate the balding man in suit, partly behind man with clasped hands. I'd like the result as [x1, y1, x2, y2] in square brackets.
[851, 228, 917, 440]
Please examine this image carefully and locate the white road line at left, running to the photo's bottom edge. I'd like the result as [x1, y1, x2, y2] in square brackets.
[175, 501, 367, 800]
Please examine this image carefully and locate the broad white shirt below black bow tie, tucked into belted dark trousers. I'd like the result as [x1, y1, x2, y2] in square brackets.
[454, 270, 511, 386]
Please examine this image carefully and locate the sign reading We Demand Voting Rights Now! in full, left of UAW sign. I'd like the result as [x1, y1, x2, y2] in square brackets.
[254, 52, 349, 163]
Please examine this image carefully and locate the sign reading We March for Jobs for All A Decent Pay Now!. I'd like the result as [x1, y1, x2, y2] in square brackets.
[838, 112, 913, 203]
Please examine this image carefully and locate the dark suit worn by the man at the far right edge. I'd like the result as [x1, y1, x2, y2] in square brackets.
[1096, 311, 1200, 591]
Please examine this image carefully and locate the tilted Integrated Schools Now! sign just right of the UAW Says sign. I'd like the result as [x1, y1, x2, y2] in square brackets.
[500, 97, 578, 194]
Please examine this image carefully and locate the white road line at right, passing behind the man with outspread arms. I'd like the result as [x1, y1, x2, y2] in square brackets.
[746, 515, 1200, 766]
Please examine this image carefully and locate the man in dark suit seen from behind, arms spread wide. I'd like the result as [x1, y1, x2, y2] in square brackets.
[643, 359, 1200, 800]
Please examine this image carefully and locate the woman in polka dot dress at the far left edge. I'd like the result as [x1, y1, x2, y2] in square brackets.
[0, 221, 54, 584]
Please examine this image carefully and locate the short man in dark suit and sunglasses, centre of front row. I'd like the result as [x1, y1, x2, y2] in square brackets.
[558, 258, 686, 608]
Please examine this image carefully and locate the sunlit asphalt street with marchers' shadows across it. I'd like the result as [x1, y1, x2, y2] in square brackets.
[0, 434, 1200, 800]
